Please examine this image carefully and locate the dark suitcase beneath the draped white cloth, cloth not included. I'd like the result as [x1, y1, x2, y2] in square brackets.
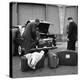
[21, 56, 45, 72]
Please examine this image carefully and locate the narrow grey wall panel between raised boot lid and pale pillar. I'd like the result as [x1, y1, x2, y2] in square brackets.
[46, 5, 60, 34]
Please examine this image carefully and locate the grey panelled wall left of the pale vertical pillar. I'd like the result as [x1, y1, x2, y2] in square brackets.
[12, 3, 60, 34]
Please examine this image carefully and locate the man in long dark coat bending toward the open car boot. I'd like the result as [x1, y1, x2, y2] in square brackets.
[22, 19, 40, 53]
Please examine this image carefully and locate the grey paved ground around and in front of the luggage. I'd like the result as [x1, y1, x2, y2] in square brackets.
[13, 42, 78, 78]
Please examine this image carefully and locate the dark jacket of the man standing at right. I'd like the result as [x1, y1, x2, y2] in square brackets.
[68, 22, 77, 41]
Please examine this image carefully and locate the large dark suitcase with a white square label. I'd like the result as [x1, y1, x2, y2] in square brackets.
[56, 50, 78, 66]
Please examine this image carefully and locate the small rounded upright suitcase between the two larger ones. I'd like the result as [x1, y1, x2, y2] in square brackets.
[48, 50, 59, 68]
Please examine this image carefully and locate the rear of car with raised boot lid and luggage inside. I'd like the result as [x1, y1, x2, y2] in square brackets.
[27, 20, 56, 50]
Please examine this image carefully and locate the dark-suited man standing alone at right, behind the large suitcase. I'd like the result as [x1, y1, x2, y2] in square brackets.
[67, 17, 77, 50]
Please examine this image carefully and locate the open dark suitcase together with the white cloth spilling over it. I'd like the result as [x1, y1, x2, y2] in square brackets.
[21, 51, 45, 72]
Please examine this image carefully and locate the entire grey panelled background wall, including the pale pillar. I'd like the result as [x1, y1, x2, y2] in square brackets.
[12, 3, 78, 41]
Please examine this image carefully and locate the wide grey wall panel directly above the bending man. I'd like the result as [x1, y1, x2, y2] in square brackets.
[18, 4, 45, 25]
